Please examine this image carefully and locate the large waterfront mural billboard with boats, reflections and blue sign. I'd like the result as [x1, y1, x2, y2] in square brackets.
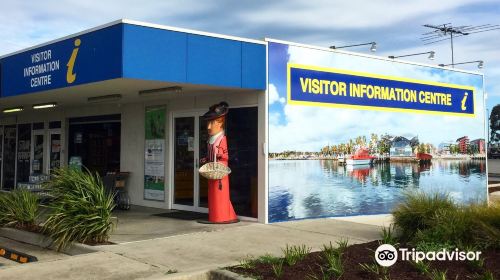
[268, 40, 487, 222]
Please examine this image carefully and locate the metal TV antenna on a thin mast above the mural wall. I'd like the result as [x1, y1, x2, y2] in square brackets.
[420, 23, 500, 67]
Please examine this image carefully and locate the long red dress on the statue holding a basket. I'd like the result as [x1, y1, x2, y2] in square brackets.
[207, 134, 238, 223]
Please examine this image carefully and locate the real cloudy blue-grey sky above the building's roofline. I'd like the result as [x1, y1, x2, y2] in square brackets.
[0, 0, 500, 107]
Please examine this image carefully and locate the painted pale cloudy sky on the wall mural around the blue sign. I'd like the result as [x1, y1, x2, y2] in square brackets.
[269, 44, 484, 152]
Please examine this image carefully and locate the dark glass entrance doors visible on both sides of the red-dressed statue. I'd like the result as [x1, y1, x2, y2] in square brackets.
[170, 106, 258, 218]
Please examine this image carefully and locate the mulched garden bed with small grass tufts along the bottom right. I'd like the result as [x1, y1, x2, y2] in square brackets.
[227, 241, 500, 280]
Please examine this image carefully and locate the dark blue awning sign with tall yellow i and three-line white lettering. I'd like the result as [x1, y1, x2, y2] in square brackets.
[1, 24, 123, 97]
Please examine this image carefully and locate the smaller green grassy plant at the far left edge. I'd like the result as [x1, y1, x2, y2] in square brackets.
[0, 190, 39, 228]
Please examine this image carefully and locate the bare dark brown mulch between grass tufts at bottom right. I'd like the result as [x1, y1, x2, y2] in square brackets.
[227, 241, 500, 280]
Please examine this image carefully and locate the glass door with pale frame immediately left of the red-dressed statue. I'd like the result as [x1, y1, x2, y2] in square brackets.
[172, 112, 208, 212]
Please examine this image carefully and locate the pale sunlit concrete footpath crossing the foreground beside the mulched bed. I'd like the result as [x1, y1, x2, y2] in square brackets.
[0, 219, 380, 280]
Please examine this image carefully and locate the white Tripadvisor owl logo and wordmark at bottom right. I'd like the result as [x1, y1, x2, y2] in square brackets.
[375, 244, 481, 266]
